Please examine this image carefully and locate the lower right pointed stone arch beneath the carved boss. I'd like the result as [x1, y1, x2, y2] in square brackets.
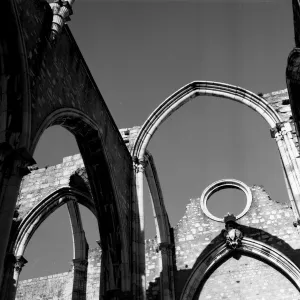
[180, 237, 300, 300]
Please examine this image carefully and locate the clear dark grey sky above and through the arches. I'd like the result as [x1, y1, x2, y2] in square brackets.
[21, 0, 294, 279]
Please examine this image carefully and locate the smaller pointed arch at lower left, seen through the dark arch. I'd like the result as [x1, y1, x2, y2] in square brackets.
[10, 188, 92, 299]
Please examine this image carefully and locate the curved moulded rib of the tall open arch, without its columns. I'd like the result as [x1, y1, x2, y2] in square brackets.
[133, 81, 282, 160]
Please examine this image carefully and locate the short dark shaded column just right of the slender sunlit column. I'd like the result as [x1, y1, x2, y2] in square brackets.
[159, 243, 175, 300]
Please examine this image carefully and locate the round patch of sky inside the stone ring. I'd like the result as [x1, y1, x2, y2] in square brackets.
[206, 187, 247, 218]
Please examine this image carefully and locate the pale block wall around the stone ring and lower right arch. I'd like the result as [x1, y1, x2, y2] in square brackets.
[146, 185, 300, 300]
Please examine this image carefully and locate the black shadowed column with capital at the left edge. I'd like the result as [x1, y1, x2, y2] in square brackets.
[0, 143, 35, 290]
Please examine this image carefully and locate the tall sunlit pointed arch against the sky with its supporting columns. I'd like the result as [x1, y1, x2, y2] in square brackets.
[132, 81, 300, 298]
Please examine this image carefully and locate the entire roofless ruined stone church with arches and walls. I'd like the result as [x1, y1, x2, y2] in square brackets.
[0, 0, 300, 300]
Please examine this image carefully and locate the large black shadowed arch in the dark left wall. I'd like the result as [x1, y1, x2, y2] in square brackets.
[30, 108, 130, 293]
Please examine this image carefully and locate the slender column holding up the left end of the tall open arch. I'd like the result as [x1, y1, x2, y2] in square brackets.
[132, 159, 146, 300]
